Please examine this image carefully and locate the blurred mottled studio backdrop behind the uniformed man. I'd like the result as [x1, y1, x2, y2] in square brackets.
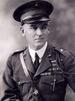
[0, 0, 75, 101]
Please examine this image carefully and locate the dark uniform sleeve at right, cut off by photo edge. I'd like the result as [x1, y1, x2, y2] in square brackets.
[64, 54, 75, 92]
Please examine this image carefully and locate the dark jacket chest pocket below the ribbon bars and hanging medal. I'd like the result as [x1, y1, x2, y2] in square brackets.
[39, 74, 64, 93]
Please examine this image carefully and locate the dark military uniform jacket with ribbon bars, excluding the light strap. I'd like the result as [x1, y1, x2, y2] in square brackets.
[1, 46, 75, 101]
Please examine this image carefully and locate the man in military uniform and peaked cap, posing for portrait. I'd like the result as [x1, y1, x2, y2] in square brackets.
[1, 0, 75, 101]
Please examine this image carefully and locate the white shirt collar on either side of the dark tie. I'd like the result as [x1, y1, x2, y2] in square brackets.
[29, 42, 48, 62]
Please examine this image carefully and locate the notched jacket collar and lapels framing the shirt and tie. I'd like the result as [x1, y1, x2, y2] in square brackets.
[24, 45, 53, 77]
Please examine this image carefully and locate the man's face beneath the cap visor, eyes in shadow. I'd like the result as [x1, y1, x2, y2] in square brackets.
[23, 22, 49, 50]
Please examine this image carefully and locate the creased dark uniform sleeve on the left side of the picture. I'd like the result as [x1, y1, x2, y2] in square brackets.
[1, 56, 20, 101]
